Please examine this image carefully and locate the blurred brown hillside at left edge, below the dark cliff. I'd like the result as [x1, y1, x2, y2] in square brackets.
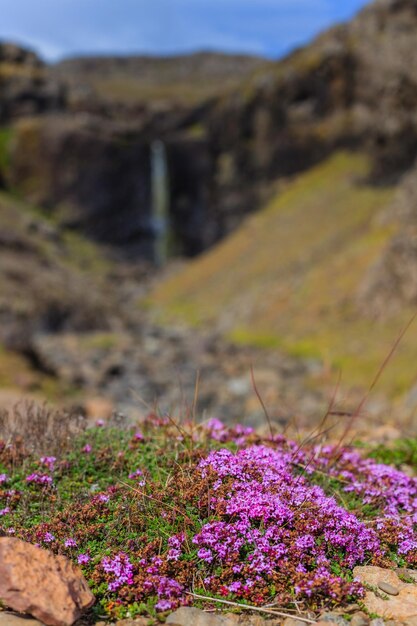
[0, 193, 136, 405]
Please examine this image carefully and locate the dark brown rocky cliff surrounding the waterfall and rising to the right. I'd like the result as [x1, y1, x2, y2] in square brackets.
[2, 0, 417, 256]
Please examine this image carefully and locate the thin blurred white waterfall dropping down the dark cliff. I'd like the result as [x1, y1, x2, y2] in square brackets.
[151, 139, 169, 266]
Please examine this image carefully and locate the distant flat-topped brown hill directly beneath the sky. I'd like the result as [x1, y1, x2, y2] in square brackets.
[50, 52, 269, 105]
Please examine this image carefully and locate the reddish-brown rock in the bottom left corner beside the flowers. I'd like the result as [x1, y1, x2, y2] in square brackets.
[0, 537, 95, 626]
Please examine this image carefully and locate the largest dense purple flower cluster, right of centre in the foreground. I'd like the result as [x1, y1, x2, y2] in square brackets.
[193, 446, 380, 597]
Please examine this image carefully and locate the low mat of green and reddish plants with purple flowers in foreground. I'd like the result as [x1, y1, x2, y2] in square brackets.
[0, 416, 417, 617]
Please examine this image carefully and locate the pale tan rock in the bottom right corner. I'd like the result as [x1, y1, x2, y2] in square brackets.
[353, 566, 417, 626]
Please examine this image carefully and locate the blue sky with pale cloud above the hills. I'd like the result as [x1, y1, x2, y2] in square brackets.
[0, 0, 366, 61]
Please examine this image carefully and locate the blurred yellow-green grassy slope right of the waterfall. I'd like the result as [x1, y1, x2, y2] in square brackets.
[150, 153, 417, 395]
